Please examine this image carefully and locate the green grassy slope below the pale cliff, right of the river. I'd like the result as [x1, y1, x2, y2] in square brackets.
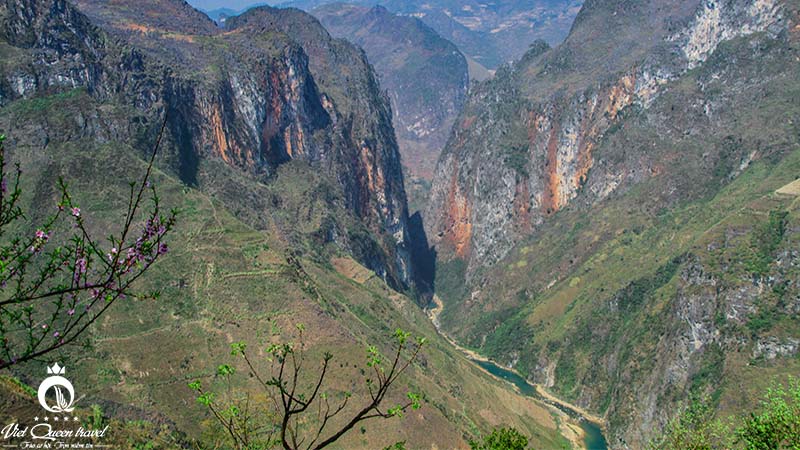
[437, 23, 800, 442]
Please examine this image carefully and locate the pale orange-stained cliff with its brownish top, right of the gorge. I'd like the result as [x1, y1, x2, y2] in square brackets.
[426, 1, 785, 269]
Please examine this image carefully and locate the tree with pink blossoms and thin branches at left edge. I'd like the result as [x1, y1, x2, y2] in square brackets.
[0, 120, 176, 369]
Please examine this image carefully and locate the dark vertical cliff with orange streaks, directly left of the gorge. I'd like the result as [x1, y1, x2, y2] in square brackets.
[19, 0, 412, 287]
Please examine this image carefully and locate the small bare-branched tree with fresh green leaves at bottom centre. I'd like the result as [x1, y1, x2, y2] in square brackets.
[189, 325, 425, 450]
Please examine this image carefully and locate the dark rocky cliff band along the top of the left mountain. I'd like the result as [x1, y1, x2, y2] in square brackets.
[0, 0, 413, 288]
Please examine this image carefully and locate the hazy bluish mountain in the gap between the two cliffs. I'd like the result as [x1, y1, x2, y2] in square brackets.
[311, 3, 469, 180]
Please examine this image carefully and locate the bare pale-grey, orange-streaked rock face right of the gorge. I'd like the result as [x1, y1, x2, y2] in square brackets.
[427, 0, 791, 268]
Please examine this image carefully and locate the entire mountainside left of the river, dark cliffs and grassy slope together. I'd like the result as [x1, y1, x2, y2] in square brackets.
[0, 0, 566, 448]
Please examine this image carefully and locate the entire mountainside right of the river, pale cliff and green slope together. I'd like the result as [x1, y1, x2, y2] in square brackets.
[426, 0, 800, 448]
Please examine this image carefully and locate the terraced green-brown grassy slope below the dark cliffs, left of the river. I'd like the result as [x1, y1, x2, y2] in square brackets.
[0, 91, 576, 448]
